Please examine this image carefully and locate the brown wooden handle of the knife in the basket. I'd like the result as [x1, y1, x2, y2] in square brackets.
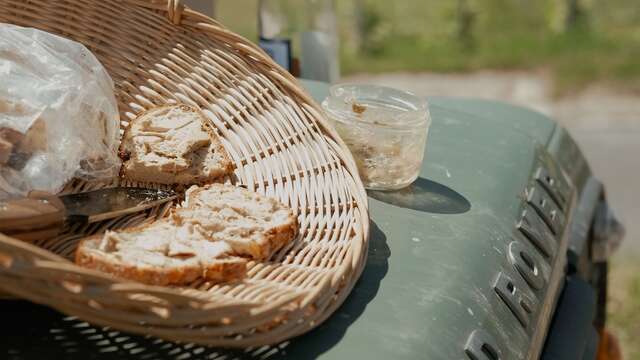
[0, 191, 66, 241]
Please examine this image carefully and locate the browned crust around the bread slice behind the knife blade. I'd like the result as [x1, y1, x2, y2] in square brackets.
[118, 104, 234, 186]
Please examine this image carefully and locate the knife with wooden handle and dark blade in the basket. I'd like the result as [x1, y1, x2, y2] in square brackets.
[0, 187, 177, 241]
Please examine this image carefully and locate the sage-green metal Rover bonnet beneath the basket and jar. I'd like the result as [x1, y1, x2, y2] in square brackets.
[286, 82, 580, 359]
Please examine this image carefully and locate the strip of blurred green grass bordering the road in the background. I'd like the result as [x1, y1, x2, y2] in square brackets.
[342, 28, 640, 95]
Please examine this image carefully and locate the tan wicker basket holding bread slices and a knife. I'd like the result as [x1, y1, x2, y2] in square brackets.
[0, 0, 369, 347]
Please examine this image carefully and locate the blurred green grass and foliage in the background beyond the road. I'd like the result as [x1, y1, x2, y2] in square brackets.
[218, 0, 640, 94]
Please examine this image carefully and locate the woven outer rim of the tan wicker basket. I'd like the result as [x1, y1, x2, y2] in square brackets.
[0, 0, 369, 347]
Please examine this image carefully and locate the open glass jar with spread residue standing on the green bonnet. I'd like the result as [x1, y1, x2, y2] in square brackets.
[322, 84, 431, 190]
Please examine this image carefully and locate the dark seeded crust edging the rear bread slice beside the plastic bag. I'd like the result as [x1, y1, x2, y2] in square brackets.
[118, 104, 234, 186]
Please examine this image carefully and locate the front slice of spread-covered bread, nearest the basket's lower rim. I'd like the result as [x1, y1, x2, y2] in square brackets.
[75, 221, 247, 286]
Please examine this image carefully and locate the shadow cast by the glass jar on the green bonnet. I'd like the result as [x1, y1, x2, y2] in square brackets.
[367, 177, 471, 214]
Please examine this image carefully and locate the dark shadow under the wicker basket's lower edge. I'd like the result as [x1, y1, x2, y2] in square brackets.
[0, 222, 391, 360]
